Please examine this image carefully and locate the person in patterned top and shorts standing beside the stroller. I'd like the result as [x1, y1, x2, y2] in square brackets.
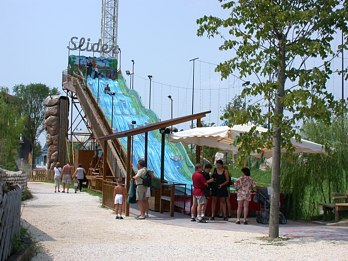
[234, 168, 256, 225]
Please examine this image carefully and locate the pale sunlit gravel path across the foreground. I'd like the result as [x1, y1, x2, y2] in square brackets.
[22, 183, 348, 260]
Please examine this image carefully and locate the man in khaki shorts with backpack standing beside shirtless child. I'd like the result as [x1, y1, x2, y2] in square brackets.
[133, 160, 147, 219]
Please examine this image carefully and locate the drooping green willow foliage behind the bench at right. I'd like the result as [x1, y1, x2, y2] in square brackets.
[282, 118, 348, 219]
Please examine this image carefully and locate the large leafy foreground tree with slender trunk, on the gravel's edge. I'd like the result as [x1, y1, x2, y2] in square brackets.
[197, 0, 347, 238]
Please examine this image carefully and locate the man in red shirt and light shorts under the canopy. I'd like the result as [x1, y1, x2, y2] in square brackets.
[191, 164, 207, 223]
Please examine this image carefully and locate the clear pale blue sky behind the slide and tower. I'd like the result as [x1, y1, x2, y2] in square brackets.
[0, 0, 346, 144]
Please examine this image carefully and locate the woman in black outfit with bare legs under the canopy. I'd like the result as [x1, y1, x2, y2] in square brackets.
[210, 160, 230, 221]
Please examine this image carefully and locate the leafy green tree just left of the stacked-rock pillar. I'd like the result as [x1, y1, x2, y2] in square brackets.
[13, 83, 59, 168]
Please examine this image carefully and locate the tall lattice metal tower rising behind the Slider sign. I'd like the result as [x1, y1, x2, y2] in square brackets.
[100, 0, 118, 57]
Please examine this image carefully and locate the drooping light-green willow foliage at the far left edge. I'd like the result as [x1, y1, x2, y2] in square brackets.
[0, 88, 23, 170]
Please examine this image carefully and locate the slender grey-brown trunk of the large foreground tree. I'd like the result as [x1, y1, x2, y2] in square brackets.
[269, 39, 285, 238]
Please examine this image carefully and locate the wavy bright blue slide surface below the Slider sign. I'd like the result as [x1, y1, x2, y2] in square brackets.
[69, 57, 194, 185]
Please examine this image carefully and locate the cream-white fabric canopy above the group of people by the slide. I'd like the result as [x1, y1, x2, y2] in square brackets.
[168, 125, 324, 158]
